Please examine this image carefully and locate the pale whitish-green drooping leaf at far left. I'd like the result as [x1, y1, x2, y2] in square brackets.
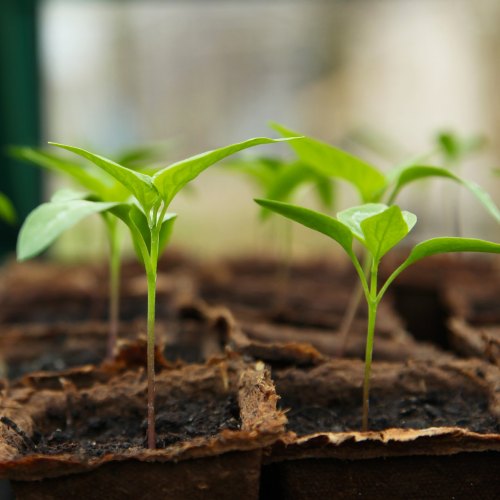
[17, 199, 118, 260]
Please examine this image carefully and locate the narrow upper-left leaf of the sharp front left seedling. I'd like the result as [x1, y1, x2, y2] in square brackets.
[49, 142, 158, 210]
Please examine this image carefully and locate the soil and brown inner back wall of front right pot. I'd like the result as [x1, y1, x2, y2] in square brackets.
[273, 363, 500, 436]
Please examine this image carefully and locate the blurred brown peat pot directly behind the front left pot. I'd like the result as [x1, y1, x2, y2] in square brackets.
[0, 302, 230, 379]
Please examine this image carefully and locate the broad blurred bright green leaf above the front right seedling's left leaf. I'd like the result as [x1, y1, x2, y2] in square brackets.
[271, 123, 386, 202]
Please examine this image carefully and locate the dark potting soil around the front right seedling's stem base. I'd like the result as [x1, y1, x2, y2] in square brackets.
[279, 390, 500, 436]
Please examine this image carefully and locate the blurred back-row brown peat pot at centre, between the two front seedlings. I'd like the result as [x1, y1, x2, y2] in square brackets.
[196, 260, 404, 335]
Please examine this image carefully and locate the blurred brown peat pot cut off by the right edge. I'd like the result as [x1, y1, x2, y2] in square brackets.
[444, 266, 500, 366]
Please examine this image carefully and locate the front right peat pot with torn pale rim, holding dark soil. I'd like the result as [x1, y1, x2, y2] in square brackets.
[261, 360, 500, 500]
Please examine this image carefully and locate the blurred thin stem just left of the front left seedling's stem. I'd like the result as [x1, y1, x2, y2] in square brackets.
[107, 218, 120, 359]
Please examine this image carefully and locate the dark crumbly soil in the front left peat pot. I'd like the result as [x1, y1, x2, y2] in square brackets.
[13, 395, 241, 458]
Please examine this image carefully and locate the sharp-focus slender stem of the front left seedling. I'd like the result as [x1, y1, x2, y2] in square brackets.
[147, 227, 159, 449]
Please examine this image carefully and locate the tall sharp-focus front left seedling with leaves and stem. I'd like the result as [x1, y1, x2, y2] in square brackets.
[20, 137, 296, 448]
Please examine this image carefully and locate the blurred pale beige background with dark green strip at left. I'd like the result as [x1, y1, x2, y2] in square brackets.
[0, 0, 500, 264]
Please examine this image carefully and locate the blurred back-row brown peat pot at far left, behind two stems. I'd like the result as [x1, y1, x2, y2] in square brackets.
[0, 253, 195, 324]
